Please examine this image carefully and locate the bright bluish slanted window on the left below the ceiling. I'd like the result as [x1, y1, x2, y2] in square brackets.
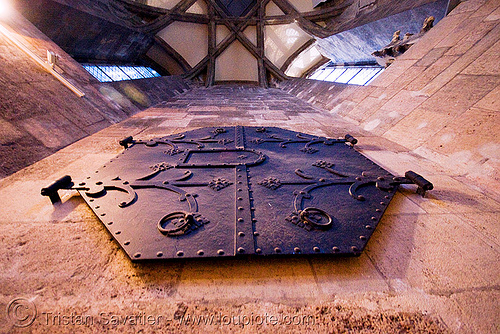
[82, 64, 161, 82]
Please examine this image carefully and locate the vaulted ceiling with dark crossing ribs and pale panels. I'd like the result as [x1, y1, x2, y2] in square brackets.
[16, 0, 436, 87]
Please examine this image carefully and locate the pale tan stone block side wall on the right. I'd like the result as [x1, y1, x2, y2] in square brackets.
[281, 0, 500, 199]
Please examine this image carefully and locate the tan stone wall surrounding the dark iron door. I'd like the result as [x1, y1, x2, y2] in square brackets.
[0, 86, 500, 333]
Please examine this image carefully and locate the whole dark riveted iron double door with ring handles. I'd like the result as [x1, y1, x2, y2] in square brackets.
[42, 126, 432, 260]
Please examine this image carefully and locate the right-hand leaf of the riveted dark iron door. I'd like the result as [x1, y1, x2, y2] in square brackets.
[249, 129, 394, 255]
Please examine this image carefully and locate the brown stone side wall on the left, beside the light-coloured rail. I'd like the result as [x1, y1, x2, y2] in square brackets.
[0, 9, 189, 178]
